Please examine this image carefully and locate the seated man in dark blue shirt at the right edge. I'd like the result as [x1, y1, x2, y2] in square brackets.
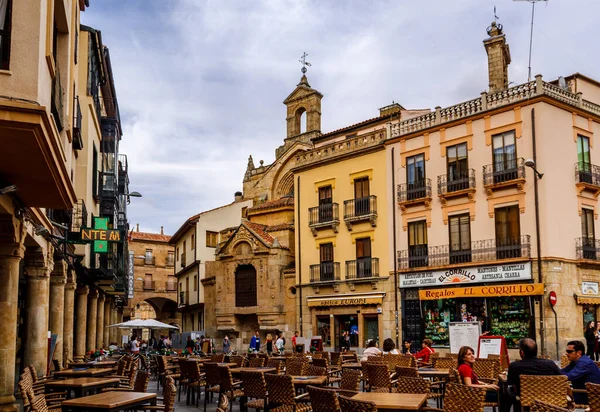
[560, 340, 600, 404]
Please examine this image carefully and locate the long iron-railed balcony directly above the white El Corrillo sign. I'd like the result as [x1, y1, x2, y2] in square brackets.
[398, 235, 531, 270]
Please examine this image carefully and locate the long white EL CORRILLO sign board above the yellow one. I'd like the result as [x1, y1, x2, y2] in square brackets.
[400, 262, 531, 288]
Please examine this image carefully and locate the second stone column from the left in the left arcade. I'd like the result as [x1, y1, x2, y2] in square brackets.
[23, 245, 54, 375]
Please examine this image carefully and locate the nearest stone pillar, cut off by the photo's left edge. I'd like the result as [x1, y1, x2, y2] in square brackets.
[0, 216, 25, 411]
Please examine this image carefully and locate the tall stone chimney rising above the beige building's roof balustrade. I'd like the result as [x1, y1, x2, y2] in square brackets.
[483, 21, 510, 93]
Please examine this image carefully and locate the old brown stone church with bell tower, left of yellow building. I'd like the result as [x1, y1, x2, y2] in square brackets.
[202, 71, 323, 350]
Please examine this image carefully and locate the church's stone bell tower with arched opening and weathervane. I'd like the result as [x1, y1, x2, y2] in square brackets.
[283, 53, 323, 143]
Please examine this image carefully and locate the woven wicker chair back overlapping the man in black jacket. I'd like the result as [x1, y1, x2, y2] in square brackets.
[521, 375, 569, 407]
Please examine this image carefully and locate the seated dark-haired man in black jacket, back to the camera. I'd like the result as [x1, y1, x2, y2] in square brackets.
[506, 338, 560, 410]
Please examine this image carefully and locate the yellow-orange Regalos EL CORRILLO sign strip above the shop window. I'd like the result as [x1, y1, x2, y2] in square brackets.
[419, 283, 544, 300]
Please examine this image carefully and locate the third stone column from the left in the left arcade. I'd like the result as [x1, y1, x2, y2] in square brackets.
[50, 260, 67, 365]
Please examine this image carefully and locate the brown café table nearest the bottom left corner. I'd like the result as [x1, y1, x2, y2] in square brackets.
[62, 392, 156, 412]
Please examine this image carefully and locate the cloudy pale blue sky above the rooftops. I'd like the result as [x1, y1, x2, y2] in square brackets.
[81, 0, 600, 234]
